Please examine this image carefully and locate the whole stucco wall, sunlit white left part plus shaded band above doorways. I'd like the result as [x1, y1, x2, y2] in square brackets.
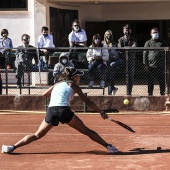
[0, 0, 170, 47]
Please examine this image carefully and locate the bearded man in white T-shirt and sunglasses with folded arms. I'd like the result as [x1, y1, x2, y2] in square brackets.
[68, 19, 87, 68]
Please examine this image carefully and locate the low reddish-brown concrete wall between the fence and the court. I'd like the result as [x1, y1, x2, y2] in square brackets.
[0, 95, 168, 113]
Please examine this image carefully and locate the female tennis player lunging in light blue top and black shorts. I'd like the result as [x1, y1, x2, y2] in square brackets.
[2, 68, 118, 153]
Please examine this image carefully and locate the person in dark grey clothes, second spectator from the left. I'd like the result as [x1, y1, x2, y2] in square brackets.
[15, 34, 38, 88]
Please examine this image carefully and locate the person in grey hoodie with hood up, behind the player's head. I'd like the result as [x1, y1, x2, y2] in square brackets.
[53, 53, 74, 83]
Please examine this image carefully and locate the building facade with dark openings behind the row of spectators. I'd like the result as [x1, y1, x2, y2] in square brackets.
[0, 0, 170, 47]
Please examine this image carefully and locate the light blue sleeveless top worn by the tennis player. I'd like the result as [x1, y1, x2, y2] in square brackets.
[49, 82, 74, 107]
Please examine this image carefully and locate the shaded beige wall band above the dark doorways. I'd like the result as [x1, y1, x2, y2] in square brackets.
[47, 2, 170, 33]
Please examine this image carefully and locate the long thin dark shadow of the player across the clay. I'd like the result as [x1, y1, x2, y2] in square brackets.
[10, 148, 170, 155]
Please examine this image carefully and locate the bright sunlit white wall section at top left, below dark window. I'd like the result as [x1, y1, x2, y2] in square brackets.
[0, 0, 35, 47]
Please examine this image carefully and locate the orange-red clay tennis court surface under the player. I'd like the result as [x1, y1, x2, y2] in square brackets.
[0, 113, 170, 170]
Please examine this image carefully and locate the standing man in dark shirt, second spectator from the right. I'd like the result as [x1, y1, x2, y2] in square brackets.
[118, 24, 137, 95]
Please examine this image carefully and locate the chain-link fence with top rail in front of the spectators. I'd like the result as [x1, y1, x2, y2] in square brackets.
[0, 47, 170, 96]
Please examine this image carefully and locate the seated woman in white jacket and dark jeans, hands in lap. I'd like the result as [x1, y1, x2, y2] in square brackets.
[86, 34, 109, 88]
